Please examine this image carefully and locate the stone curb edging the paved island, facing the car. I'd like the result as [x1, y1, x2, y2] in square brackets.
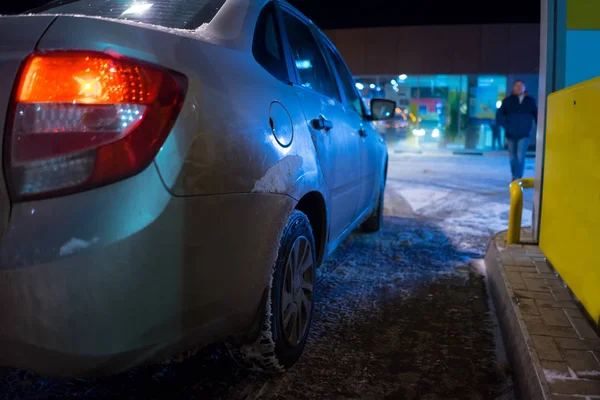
[485, 232, 552, 400]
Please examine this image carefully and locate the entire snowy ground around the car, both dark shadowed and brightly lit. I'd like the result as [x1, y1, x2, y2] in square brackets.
[0, 155, 533, 400]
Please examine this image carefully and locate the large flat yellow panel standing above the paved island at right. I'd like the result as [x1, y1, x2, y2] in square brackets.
[540, 77, 600, 323]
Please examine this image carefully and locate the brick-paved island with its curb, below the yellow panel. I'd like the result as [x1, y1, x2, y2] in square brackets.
[486, 231, 600, 400]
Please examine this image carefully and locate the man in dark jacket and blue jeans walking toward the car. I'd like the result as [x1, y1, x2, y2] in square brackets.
[497, 80, 537, 181]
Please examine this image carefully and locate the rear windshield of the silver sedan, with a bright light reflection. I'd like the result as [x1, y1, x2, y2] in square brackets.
[29, 0, 226, 30]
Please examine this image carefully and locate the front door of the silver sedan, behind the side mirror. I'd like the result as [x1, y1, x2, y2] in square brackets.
[322, 42, 381, 216]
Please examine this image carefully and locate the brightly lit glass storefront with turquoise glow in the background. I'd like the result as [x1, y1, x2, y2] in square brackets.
[355, 74, 537, 151]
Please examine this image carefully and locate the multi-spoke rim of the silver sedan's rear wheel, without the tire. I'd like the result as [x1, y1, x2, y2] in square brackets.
[281, 236, 314, 346]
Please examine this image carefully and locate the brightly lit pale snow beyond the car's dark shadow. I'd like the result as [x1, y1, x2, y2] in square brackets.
[386, 155, 534, 252]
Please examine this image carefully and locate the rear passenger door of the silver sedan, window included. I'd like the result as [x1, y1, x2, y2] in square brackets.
[282, 4, 361, 240]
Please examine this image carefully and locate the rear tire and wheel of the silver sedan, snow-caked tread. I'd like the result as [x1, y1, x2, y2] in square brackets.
[229, 210, 317, 373]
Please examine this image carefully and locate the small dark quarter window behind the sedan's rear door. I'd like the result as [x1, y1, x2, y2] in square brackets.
[252, 3, 289, 82]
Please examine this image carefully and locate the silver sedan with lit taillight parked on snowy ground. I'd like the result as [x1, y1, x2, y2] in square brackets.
[0, 0, 395, 376]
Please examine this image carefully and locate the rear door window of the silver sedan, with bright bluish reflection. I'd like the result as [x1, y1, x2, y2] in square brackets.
[283, 12, 339, 100]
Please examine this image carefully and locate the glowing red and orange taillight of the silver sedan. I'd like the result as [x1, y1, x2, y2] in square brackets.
[5, 51, 187, 200]
